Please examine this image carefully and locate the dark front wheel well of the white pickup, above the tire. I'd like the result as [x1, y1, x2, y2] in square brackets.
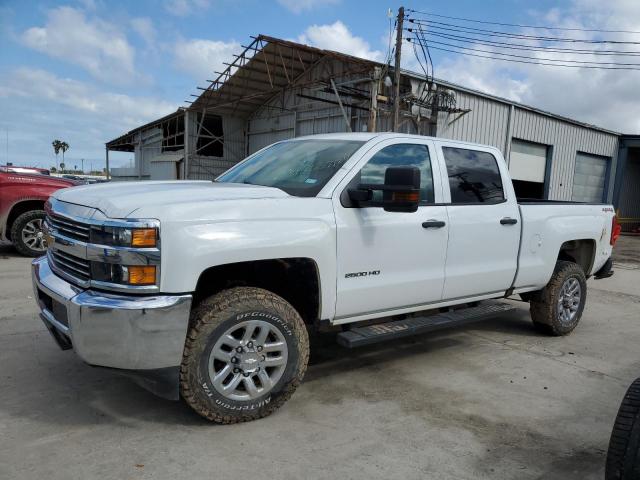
[194, 258, 320, 324]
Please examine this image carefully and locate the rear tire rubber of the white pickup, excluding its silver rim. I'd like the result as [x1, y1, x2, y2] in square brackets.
[529, 260, 587, 336]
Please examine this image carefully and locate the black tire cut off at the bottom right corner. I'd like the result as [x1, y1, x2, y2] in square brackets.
[605, 378, 640, 480]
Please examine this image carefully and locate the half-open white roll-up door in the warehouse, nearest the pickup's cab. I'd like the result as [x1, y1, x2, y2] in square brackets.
[509, 138, 550, 199]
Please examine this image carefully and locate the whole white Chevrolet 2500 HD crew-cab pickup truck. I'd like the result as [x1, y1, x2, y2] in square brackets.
[33, 133, 619, 423]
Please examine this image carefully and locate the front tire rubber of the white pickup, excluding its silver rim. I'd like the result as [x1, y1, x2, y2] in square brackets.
[180, 287, 309, 424]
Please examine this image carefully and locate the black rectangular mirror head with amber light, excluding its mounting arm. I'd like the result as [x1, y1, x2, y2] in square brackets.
[382, 167, 420, 212]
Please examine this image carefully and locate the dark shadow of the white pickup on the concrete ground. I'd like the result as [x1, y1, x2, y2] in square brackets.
[7, 318, 536, 429]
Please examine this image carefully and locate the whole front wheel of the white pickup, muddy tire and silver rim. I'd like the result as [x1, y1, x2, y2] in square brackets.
[180, 287, 309, 424]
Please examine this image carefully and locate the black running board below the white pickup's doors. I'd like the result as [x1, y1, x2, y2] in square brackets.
[338, 301, 515, 348]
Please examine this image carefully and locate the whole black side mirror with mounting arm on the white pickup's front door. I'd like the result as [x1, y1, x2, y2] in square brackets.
[348, 167, 420, 212]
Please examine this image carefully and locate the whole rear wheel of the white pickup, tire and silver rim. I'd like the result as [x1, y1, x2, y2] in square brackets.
[530, 261, 587, 336]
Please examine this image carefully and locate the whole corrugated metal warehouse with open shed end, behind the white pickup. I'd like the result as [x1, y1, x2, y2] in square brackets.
[106, 35, 640, 229]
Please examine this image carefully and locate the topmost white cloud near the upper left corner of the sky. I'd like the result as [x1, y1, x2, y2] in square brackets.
[20, 7, 137, 84]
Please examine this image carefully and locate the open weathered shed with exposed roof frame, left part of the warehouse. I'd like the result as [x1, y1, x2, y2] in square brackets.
[106, 35, 464, 179]
